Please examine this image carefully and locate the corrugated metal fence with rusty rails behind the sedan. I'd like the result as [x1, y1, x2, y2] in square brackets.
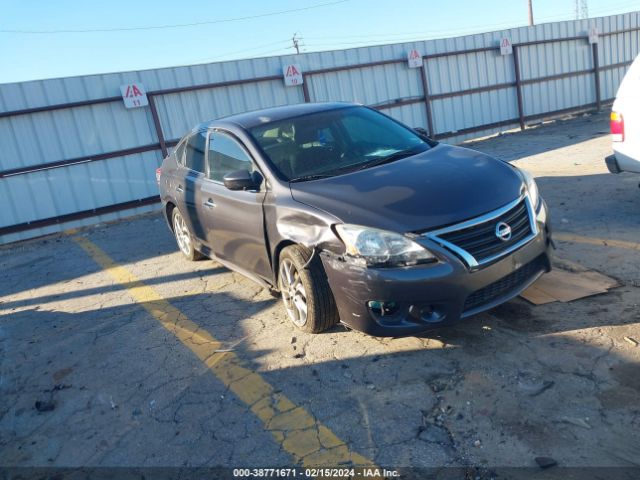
[0, 12, 640, 243]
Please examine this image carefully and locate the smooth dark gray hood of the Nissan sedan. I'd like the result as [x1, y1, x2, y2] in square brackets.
[290, 144, 523, 232]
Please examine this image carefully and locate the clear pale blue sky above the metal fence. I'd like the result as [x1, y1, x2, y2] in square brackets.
[0, 0, 640, 83]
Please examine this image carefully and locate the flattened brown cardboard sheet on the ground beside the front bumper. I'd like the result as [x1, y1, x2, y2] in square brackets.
[520, 269, 618, 305]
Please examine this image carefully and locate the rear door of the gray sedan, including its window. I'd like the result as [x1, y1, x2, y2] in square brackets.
[176, 130, 207, 241]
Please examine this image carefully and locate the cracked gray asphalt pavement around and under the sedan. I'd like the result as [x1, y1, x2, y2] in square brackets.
[0, 109, 640, 467]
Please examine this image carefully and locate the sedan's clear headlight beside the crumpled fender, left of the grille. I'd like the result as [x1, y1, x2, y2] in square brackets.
[336, 224, 436, 267]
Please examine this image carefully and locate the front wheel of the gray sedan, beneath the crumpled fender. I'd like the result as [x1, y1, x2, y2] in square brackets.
[278, 245, 339, 333]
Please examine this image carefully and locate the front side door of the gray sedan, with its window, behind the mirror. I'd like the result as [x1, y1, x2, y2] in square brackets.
[201, 130, 271, 279]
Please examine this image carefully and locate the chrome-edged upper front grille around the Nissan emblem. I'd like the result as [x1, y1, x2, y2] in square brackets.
[429, 198, 536, 267]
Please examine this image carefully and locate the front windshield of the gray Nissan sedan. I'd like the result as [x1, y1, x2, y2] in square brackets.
[250, 107, 430, 182]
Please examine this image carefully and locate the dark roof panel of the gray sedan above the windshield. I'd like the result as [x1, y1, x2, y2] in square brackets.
[194, 102, 358, 130]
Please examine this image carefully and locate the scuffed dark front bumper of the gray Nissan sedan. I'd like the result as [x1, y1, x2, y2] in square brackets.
[321, 201, 551, 336]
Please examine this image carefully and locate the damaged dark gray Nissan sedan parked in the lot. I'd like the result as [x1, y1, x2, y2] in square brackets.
[158, 103, 551, 336]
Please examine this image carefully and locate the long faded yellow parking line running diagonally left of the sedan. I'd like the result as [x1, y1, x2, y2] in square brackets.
[73, 237, 374, 467]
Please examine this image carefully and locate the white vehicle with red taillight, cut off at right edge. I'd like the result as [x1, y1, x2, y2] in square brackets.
[605, 55, 640, 173]
